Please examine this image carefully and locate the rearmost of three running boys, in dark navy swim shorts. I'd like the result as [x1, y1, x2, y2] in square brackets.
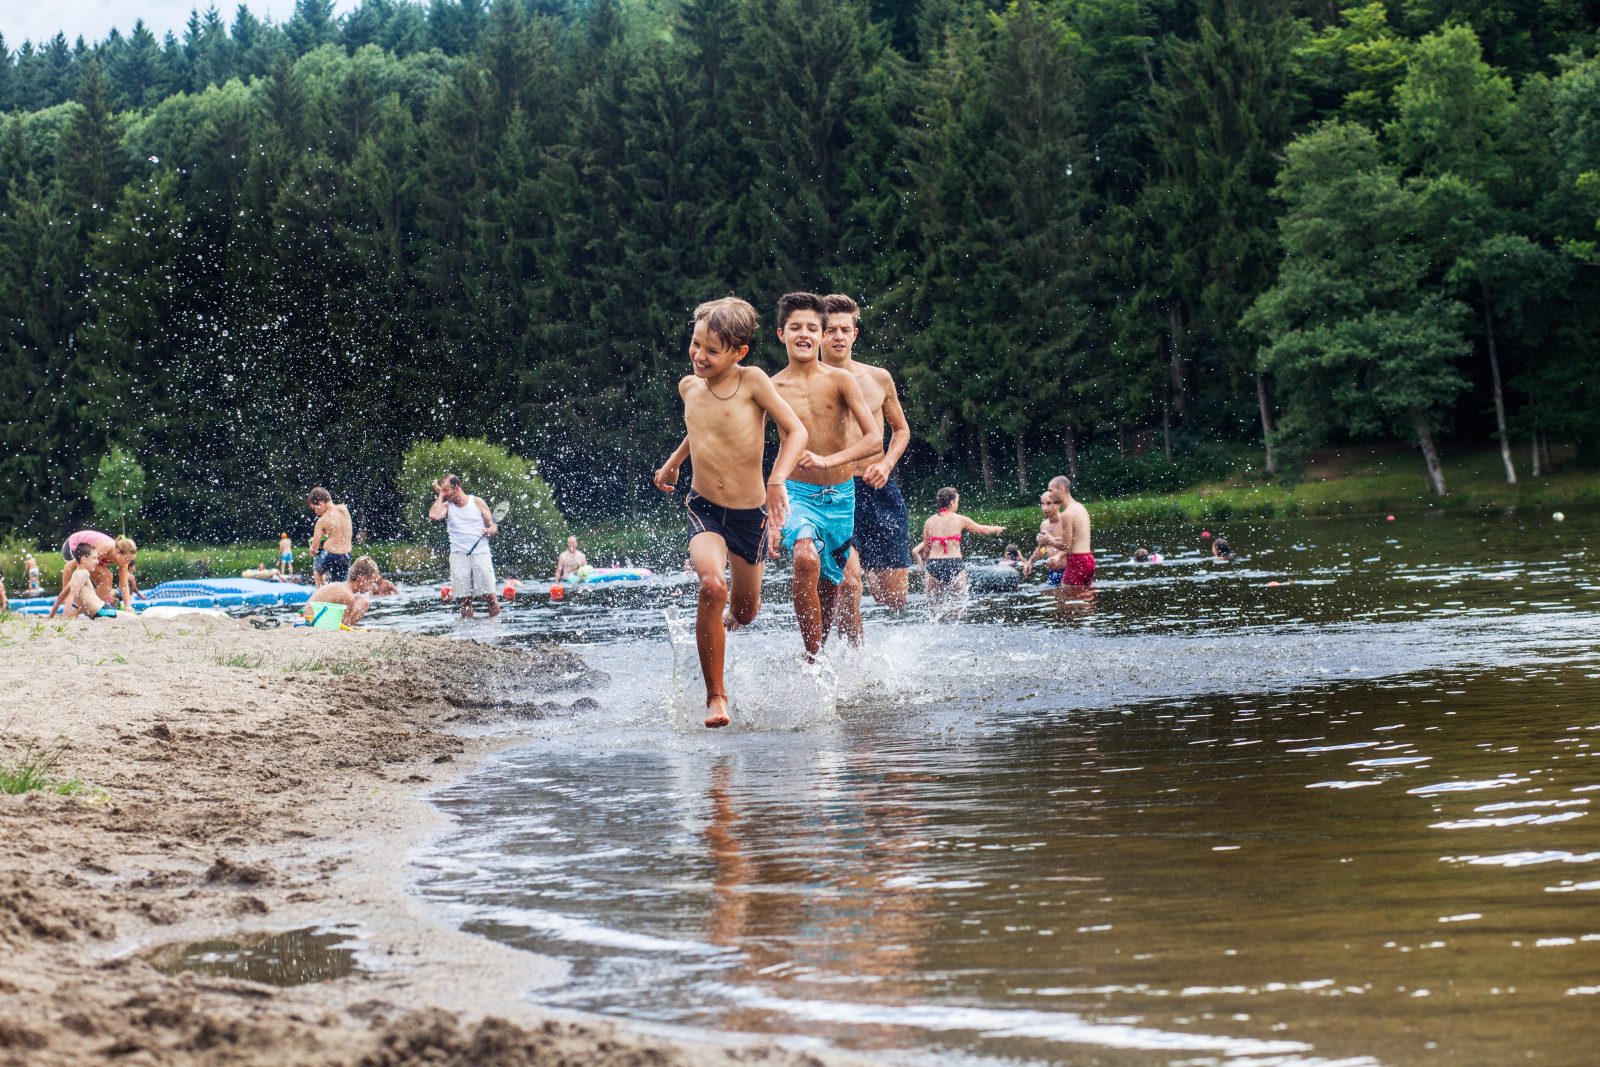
[822, 293, 910, 641]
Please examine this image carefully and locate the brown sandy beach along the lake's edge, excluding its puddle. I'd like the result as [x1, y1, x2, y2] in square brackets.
[0, 616, 858, 1067]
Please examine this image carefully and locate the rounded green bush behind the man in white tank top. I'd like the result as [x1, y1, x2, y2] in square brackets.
[398, 437, 566, 563]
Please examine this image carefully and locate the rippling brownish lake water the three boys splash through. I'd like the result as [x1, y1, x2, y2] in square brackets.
[374, 515, 1600, 1067]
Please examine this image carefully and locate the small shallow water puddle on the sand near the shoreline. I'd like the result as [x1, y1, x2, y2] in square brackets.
[144, 926, 360, 985]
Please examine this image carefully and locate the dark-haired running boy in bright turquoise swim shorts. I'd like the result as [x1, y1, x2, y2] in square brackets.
[773, 293, 883, 659]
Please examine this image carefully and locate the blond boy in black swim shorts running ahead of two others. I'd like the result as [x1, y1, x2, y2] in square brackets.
[656, 296, 806, 728]
